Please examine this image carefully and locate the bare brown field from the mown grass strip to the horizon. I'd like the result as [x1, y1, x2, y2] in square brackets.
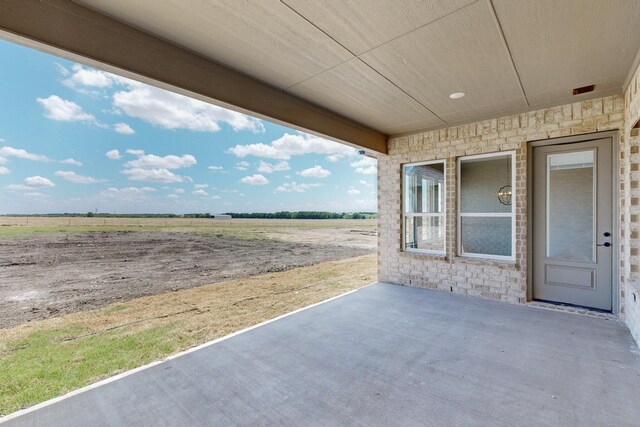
[0, 218, 377, 328]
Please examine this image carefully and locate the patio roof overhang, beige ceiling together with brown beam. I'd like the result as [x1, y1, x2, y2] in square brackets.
[0, 0, 640, 153]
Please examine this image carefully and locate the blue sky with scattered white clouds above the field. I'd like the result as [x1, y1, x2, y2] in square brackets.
[0, 41, 376, 214]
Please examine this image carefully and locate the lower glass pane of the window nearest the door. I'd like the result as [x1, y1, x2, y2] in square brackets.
[460, 216, 512, 257]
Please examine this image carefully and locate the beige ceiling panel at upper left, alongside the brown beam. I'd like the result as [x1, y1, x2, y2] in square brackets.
[76, 0, 353, 88]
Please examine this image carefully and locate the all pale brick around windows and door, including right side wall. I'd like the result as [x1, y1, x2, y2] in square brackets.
[378, 61, 640, 348]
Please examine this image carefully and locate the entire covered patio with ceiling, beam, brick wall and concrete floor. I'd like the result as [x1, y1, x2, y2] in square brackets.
[0, 0, 640, 425]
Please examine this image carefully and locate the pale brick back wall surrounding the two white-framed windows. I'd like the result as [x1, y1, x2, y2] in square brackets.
[378, 94, 624, 305]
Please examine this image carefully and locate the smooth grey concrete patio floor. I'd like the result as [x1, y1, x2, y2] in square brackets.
[1, 284, 640, 426]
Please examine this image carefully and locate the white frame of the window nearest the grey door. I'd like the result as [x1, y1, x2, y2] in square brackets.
[456, 151, 517, 261]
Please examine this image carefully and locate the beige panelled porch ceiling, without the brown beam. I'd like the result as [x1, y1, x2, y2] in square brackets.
[75, 0, 640, 134]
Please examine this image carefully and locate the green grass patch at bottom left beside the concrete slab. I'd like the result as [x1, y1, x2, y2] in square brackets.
[0, 323, 179, 413]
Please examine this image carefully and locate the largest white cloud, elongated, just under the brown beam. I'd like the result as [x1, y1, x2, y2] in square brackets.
[113, 81, 264, 133]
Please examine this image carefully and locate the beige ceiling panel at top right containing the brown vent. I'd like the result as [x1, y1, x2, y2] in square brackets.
[493, 0, 640, 106]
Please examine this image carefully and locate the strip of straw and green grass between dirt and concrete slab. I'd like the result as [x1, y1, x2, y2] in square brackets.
[0, 255, 376, 415]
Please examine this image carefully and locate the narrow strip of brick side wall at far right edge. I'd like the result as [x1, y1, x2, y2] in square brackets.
[620, 61, 640, 345]
